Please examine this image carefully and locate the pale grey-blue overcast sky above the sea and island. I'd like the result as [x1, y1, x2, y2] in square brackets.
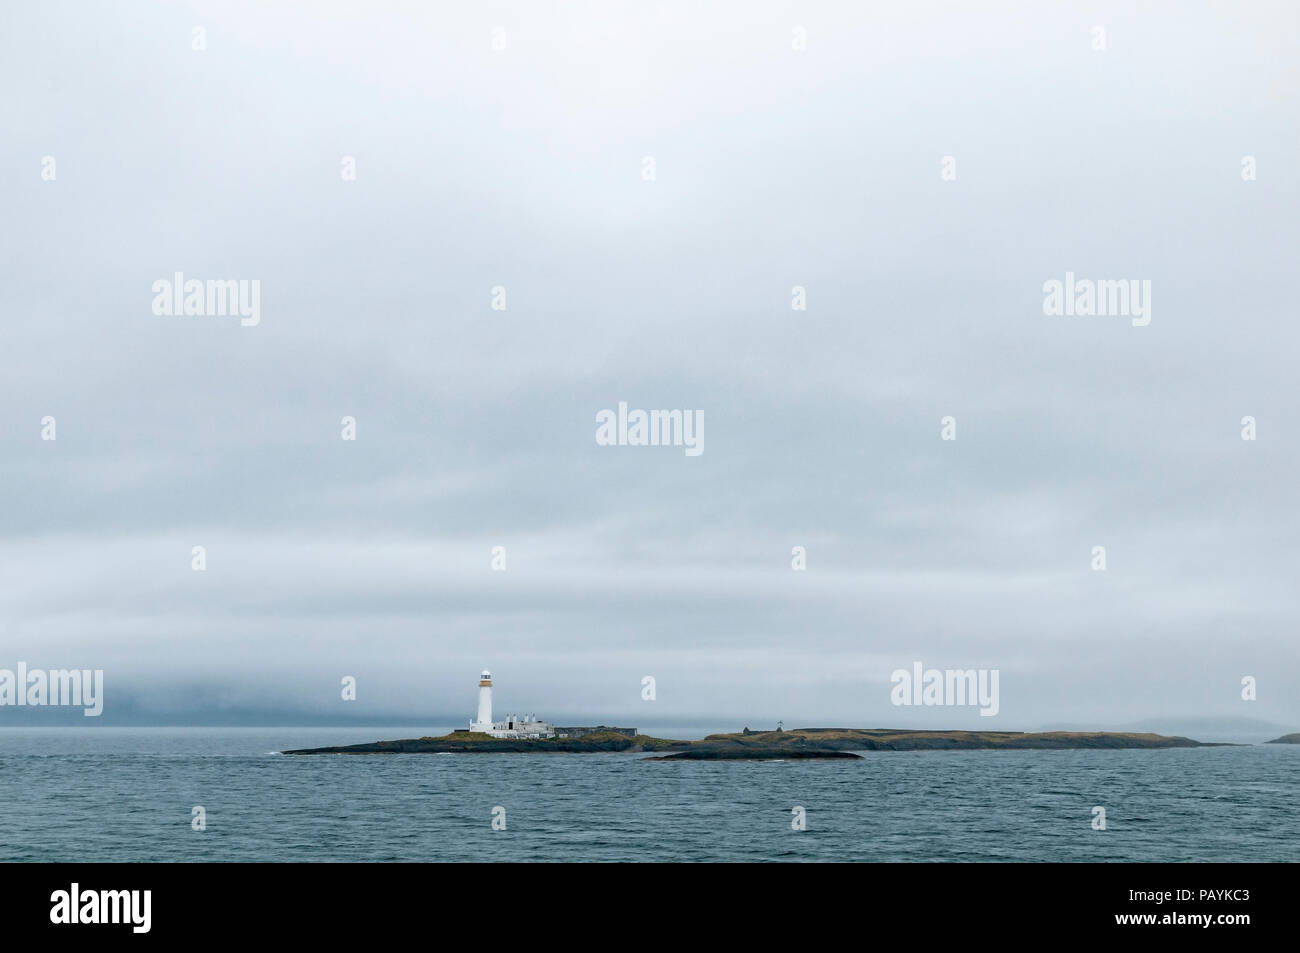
[0, 3, 1300, 731]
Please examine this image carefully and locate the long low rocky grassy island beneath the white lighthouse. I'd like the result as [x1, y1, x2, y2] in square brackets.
[283, 728, 1216, 761]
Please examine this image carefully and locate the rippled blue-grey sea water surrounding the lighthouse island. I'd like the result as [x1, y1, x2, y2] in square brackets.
[0, 725, 1300, 862]
